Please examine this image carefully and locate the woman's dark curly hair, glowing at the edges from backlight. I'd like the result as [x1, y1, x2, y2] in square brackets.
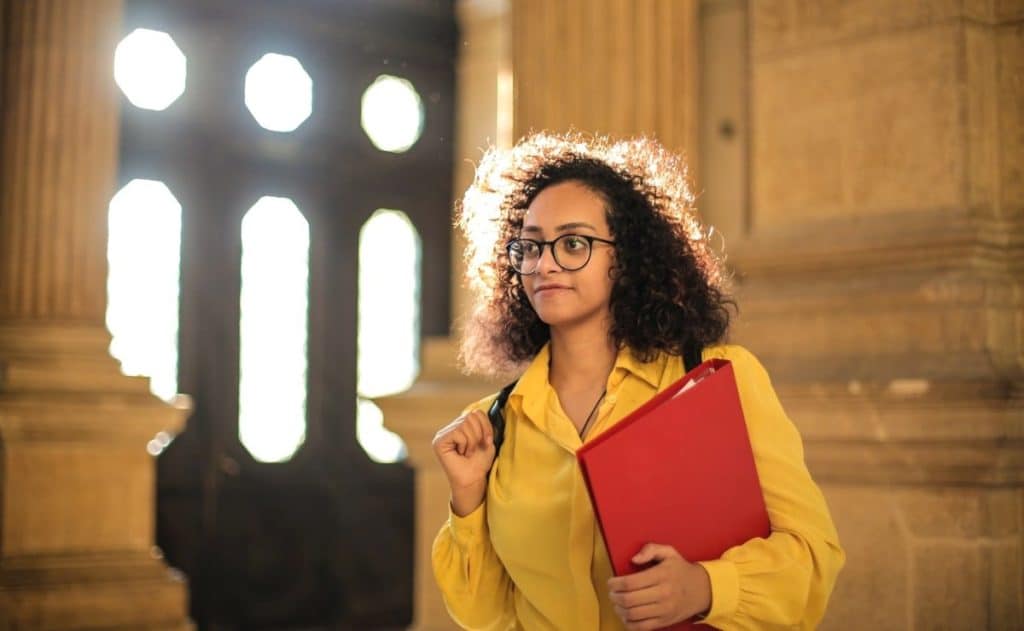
[457, 132, 735, 377]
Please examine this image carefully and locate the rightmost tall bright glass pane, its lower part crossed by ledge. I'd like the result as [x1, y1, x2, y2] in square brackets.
[357, 209, 422, 462]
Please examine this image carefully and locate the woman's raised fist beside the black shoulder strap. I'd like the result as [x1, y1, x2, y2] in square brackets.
[433, 410, 496, 516]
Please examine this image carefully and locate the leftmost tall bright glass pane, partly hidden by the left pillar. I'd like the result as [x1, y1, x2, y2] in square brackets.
[106, 179, 181, 401]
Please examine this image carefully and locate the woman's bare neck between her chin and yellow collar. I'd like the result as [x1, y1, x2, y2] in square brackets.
[548, 319, 618, 390]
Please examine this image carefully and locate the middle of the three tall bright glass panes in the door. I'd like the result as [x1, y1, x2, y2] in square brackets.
[239, 197, 309, 462]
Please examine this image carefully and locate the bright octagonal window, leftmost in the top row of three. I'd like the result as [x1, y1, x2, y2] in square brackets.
[114, 29, 186, 111]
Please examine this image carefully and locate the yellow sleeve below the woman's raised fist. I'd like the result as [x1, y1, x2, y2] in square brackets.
[431, 396, 515, 631]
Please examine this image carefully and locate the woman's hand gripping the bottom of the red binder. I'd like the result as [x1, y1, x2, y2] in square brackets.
[608, 543, 711, 631]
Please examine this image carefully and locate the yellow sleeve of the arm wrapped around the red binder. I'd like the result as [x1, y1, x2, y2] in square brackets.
[700, 346, 846, 629]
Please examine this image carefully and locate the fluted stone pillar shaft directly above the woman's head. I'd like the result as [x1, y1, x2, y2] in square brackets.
[512, 0, 698, 168]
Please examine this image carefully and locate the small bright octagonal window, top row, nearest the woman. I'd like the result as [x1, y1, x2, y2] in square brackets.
[361, 75, 423, 154]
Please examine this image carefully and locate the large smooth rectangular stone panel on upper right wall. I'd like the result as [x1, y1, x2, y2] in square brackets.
[753, 26, 966, 225]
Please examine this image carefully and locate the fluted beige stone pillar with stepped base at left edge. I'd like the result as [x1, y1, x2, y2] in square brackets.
[0, 0, 190, 629]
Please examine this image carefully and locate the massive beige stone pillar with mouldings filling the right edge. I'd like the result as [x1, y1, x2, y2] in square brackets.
[720, 0, 1024, 629]
